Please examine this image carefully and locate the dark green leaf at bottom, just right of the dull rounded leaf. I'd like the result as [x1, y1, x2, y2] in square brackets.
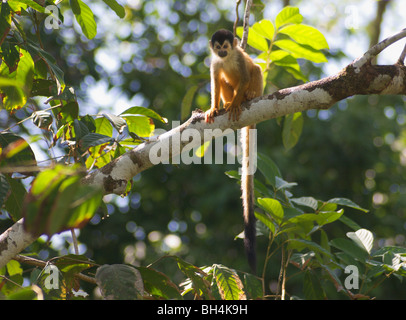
[137, 267, 183, 300]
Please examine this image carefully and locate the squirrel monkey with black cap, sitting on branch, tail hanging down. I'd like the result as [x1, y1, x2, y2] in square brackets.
[205, 29, 263, 272]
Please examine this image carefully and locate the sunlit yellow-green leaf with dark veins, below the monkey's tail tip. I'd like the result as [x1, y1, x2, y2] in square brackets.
[213, 265, 246, 300]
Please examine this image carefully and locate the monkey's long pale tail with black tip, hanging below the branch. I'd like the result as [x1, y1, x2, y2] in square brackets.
[241, 125, 256, 274]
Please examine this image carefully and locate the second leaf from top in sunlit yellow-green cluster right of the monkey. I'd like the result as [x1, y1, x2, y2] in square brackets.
[279, 24, 328, 50]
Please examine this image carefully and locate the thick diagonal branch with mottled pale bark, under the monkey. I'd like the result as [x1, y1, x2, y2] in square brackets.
[0, 29, 406, 268]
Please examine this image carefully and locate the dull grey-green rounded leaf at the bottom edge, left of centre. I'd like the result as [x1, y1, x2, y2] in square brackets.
[96, 264, 144, 300]
